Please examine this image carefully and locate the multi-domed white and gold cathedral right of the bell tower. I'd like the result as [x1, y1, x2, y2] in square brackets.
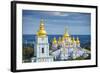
[52, 29, 81, 60]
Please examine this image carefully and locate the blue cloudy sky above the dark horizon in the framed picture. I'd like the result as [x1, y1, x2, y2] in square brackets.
[22, 10, 91, 35]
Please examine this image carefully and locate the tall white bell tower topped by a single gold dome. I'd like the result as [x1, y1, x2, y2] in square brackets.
[34, 19, 53, 62]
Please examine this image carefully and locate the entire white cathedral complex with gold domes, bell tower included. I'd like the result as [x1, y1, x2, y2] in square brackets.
[32, 19, 88, 62]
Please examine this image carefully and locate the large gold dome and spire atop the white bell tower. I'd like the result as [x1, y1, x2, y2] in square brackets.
[37, 19, 47, 37]
